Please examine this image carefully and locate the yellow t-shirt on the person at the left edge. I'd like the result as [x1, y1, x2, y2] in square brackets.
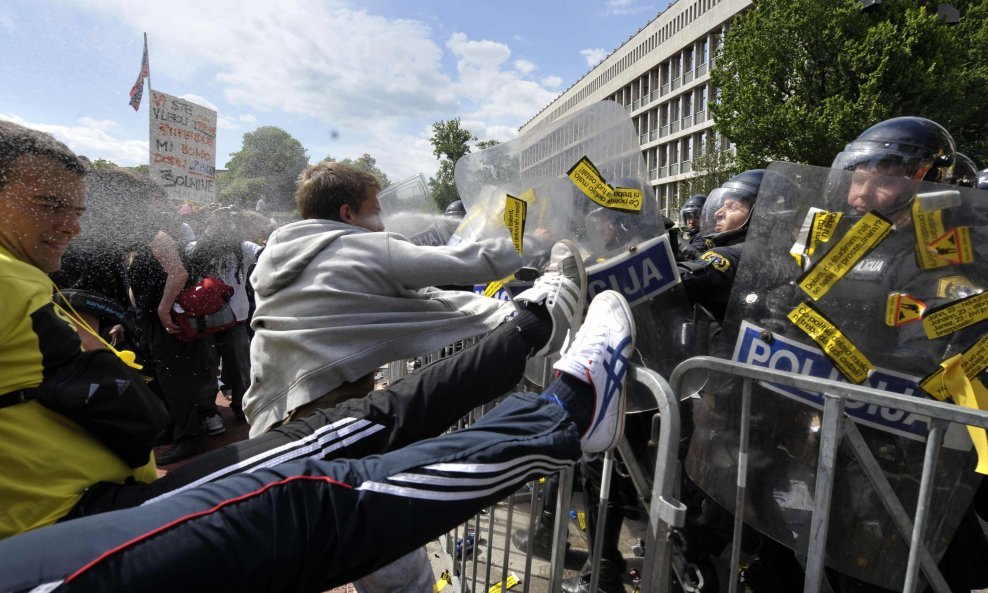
[0, 247, 156, 538]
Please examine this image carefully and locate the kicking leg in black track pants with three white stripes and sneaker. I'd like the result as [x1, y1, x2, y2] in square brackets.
[73, 243, 586, 508]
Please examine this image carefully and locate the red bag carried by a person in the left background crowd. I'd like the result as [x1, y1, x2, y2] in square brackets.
[172, 276, 237, 342]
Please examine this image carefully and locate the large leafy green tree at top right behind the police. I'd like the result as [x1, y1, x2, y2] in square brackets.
[711, 0, 988, 170]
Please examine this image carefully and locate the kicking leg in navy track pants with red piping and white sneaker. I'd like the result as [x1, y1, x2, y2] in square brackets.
[0, 292, 633, 591]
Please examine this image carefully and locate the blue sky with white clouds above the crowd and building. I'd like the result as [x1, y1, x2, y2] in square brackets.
[0, 0, 668, 180]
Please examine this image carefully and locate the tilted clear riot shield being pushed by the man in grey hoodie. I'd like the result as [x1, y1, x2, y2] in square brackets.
[451, 101, 689, 374]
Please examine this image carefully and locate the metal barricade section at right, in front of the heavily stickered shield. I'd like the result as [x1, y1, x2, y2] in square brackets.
[641, 356, 988, 593]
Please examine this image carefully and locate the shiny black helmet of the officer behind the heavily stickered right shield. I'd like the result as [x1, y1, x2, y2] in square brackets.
[830, 116, 956, 182]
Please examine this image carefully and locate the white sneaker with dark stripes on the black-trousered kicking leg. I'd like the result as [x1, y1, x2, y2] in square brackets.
[514, 239, 587, 356]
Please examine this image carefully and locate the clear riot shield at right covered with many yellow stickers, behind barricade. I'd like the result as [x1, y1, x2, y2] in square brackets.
[686, 163, 988, 589]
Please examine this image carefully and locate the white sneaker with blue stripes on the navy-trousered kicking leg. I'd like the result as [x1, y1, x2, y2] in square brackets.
[553, 290, 635, 453]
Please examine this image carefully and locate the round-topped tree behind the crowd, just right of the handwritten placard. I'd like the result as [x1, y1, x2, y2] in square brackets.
[216, 126, 309, 210]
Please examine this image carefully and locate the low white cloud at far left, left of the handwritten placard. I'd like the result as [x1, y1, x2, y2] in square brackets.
[0, 113, 148, 167]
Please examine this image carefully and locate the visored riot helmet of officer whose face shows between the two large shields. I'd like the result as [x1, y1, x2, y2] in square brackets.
[700, 169, 765, 246]
